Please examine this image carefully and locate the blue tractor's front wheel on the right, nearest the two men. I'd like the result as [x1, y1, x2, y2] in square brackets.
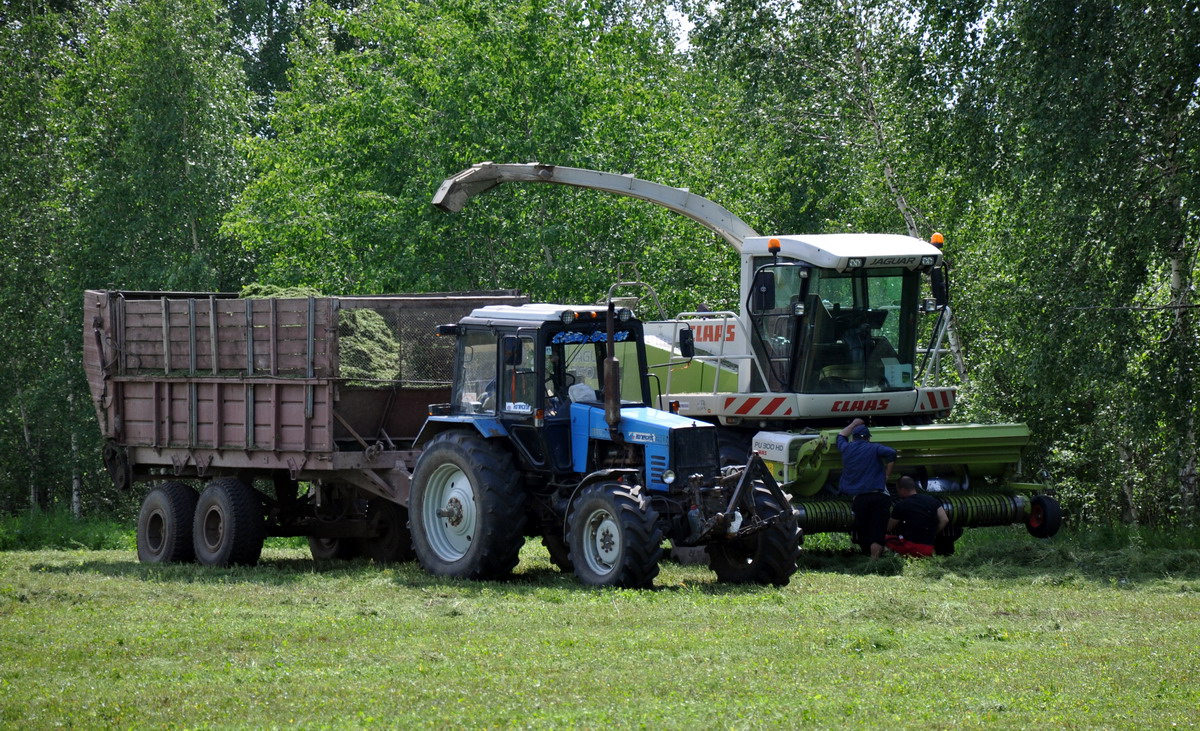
[707, 486, 800, 586]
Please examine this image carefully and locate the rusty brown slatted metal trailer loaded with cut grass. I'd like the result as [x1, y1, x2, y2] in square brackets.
[84, 290, 528, 563]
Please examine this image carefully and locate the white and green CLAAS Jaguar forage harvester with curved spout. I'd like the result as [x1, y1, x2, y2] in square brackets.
[433, 162, 1062, 552]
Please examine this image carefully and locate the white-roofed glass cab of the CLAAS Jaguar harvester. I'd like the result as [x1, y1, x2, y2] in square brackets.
[743, 234, 941, 394]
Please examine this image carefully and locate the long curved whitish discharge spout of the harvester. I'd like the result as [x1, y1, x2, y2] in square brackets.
[433, 162, 758, 253]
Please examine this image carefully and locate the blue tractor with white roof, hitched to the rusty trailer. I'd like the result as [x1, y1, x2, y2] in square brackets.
[409, 304, 799, 587]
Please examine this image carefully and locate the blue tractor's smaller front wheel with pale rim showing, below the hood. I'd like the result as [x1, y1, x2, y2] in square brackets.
[566, 483, 662, 588]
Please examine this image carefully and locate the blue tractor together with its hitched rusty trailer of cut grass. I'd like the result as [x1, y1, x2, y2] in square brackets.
[84, 292, 799, 587]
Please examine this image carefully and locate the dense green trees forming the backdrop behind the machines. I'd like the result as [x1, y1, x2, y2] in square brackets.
[0, 0, 1200, 521]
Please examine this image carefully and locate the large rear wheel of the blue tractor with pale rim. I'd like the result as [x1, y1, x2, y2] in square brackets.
[409, 430, 526, 579]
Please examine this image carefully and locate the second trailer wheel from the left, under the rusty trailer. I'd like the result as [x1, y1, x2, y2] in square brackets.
[192, 478, 266, 567]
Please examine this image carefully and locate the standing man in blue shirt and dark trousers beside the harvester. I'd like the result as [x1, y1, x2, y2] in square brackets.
[838, 419, 896, 558]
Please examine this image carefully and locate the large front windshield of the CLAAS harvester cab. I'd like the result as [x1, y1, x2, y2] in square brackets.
[793, 269, 919, 394]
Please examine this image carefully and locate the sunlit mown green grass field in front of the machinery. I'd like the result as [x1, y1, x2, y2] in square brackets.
[0, 529, 1200, 729]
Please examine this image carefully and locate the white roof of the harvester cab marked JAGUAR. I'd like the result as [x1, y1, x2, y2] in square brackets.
[742, 234, 942, 271]
